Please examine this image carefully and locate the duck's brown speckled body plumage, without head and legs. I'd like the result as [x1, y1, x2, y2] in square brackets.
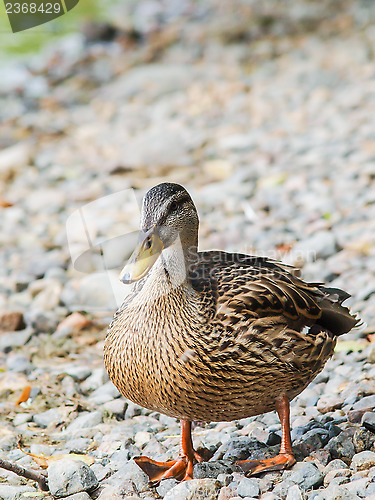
[105, 246, 357, 421]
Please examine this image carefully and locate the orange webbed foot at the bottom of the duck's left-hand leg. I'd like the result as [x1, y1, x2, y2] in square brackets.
[134, 452, 206, 486]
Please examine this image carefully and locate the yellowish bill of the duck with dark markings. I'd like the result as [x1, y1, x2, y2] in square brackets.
[120, 228, 164, 284]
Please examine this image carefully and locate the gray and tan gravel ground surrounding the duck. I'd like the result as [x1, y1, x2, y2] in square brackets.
[0, 0, 375, 500]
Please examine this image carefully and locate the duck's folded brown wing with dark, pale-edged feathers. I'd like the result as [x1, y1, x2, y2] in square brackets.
[192, 251, 359, 337]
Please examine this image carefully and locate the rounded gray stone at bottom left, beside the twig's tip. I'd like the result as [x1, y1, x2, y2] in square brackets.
[48, 458, 98, 498]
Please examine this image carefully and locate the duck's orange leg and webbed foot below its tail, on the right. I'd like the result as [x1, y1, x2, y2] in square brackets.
[237, 395, 296, 475]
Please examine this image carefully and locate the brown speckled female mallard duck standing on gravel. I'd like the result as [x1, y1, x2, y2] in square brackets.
[104, 183, 357, 484]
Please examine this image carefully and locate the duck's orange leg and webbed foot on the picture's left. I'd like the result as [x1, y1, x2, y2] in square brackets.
[134, 420, 203, 486]
